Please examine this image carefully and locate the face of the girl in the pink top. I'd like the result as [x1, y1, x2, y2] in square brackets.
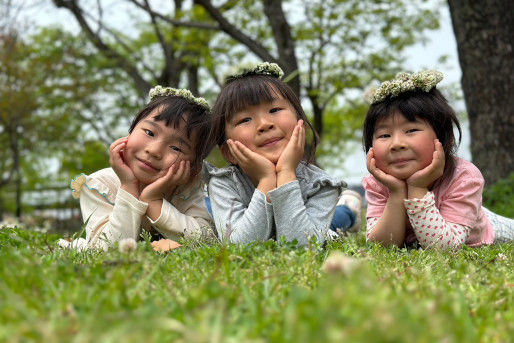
[373, 113, 437, 180]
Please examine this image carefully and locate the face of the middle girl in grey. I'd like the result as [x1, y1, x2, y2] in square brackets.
[225, 95, 298, 164]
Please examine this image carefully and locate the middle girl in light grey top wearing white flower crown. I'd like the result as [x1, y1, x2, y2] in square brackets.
[204, 63, 355, 245]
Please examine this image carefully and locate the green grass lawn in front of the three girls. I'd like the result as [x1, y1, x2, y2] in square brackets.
[0, 228, 514, 343]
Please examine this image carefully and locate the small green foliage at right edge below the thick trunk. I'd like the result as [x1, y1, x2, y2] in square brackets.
[483, 173, 514, 218]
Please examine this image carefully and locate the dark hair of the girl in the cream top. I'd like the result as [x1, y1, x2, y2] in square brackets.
[129, 96, 214, 171]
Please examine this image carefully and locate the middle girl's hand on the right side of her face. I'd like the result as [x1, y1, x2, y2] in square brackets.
[276, 120, 305, 175]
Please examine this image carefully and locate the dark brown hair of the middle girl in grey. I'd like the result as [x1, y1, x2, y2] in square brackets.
[212, 74, 319, 162]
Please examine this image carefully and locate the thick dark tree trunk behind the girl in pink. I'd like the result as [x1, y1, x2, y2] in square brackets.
[448, 0, 514, 184]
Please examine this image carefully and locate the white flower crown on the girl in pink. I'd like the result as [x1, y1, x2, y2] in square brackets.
[370, 70, 443, 104]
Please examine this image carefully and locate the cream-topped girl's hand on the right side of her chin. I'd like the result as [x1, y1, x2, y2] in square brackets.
[140, 161, 191, 203]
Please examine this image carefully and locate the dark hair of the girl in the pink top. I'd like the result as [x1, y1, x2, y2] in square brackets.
[362, 88, 462, 183]
